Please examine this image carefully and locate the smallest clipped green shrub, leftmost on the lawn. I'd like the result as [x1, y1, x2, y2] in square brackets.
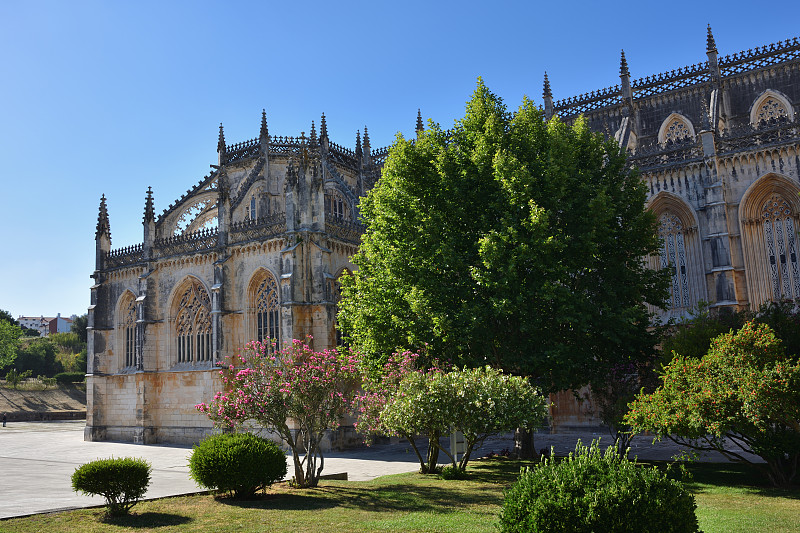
[72, 457, 152, 516]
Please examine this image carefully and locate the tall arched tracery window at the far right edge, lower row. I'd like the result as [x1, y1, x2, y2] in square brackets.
[761, 194, 800, 300]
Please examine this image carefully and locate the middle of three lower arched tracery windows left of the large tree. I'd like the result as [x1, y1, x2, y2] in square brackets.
[175, 280, 212, 363]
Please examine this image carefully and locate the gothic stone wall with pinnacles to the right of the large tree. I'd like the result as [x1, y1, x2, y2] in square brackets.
[544, 27, 800, 425]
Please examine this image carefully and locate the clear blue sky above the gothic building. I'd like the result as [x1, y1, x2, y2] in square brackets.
[0, 0, 800, 317]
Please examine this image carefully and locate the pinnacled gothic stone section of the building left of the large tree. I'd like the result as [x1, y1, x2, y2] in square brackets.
[85, 115, 387, 443]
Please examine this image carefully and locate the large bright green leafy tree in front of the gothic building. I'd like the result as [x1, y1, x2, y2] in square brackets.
[339, 80, 666, 390]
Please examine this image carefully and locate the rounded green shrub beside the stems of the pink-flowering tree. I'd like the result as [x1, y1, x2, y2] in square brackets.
[189, 433, 286, 498]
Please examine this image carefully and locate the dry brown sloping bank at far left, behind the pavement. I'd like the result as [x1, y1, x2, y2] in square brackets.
[0, 386, 86, 422]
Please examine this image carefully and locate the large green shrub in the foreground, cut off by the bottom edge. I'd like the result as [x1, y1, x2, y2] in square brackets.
[500, 442, 699, 533]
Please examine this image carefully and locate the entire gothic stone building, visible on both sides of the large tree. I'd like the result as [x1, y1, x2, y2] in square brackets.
[86, 28, 800, 442]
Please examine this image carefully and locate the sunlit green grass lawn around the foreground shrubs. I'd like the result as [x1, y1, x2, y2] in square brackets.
[0, 459, 800, 533]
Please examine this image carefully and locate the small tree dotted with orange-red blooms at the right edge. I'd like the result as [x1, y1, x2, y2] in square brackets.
[625, 322, 800, 486]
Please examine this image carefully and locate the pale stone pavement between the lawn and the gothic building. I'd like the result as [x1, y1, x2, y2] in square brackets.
[0, 420, 756, 519]
